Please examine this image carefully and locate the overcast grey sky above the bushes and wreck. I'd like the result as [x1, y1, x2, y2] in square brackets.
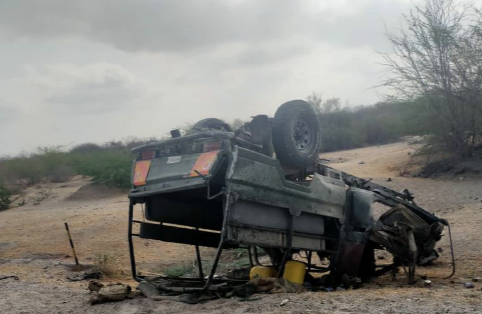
[0, 0, 417, 156]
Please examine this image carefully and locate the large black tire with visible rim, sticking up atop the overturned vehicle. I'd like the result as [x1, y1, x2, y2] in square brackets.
[273, 100, 321, 169]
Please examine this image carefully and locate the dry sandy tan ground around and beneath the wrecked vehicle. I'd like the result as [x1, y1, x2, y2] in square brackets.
[0, 143, 482, 313]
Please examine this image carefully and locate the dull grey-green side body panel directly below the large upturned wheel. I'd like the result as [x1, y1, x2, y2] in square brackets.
[226, 146, 346, 220]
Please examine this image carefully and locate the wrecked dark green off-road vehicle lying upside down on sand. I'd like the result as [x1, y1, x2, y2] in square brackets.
[129, 100, 448, 290]
